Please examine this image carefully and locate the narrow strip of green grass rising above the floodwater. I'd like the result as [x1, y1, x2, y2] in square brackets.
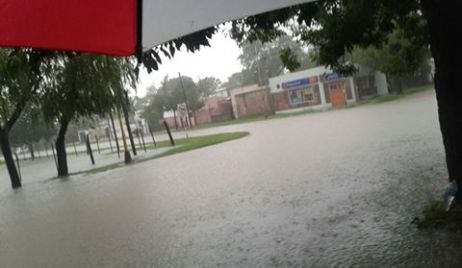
[61, 132, 250, 180]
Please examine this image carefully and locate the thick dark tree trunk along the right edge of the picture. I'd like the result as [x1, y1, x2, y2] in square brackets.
[421, 0, 462, 203]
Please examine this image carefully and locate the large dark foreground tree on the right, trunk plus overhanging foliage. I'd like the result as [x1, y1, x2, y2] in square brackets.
[227, 0, 462, 204]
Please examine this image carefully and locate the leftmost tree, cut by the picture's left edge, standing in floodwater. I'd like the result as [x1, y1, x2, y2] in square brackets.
[0, 49, 45, 188]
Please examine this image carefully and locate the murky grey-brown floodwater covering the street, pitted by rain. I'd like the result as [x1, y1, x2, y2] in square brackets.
[0, 92, 462, 267]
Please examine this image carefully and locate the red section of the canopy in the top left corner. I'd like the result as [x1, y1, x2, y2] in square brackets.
[0, 0, 137, 56]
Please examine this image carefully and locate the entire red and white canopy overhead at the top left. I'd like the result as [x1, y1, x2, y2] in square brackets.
[0, 0, 314, 56]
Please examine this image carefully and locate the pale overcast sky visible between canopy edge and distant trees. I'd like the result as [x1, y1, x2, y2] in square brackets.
[137, 31, 242, 97]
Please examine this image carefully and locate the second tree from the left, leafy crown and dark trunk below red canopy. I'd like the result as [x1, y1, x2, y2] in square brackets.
[42, 53, 134, 176]
